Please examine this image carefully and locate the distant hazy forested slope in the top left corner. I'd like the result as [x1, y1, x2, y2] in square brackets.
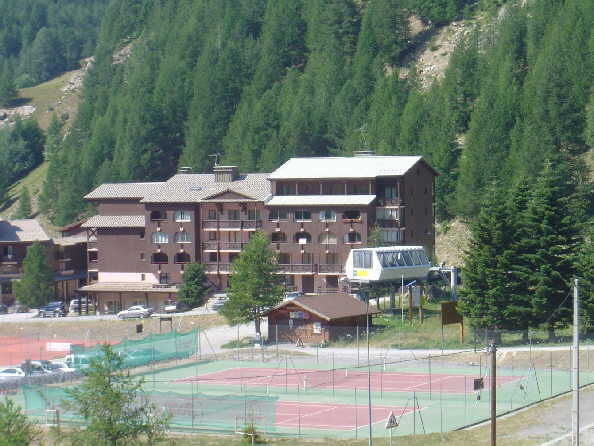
[0, 0, 108, 99]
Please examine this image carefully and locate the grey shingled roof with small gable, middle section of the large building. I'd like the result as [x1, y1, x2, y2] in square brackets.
[141, 173, 271, 203]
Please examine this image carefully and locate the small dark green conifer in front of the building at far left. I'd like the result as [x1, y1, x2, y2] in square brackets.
[14, 242, 55, 308]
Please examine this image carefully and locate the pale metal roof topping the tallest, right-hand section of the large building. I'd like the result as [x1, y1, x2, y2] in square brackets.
[269, 155, 422, 180]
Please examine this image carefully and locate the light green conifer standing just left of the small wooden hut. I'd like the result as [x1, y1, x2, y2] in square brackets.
[221, 232, 283, 335]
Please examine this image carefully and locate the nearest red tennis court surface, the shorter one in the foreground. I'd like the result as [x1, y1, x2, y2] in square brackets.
[275, 401, 413, 430]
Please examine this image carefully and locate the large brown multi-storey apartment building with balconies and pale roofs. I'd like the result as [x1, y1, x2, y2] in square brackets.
[81, 153, 437, 312]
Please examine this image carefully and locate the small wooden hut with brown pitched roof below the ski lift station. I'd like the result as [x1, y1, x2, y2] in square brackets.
[267, 294, 379, 344]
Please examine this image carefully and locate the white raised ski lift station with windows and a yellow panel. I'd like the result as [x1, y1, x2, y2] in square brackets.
[346, 246, 432, 282]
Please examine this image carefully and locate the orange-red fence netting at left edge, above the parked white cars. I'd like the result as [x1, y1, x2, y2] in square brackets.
[0, 336, 96, 366]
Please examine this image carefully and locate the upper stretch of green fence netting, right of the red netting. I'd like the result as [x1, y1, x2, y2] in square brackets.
[69, 329, 198, 370]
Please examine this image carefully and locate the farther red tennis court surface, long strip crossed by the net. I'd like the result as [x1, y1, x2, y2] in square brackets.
[174, 368, 521, 393]
